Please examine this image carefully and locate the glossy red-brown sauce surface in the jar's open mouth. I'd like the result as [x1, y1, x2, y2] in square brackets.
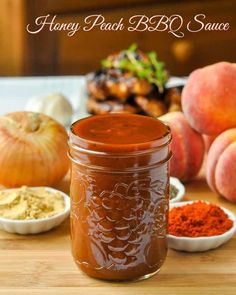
[72, 114, 168, 150]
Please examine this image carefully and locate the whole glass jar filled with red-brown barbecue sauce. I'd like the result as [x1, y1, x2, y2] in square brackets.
[69, 114, 171, 281]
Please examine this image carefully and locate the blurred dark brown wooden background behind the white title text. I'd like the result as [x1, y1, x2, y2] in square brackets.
[0, 0, 236, 75]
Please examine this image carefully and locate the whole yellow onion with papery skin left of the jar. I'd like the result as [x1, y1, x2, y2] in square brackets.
[0, 112, 69, 187]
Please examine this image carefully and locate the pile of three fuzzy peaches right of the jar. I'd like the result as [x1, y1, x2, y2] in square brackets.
[160, 62, 236, 202]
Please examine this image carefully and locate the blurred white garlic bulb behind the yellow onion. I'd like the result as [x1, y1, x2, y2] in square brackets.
[25, 93, 73, 126]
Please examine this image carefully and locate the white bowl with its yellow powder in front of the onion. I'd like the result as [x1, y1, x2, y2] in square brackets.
[0, 186, 70, 234]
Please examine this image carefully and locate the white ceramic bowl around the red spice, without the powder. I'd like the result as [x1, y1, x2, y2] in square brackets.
[167, 201, 236, 252]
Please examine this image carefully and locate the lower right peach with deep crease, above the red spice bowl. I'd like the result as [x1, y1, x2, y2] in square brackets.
[206, 128, 236, 202]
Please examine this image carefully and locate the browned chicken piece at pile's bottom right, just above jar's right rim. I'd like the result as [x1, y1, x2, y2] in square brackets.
[134, 96, 167, 118]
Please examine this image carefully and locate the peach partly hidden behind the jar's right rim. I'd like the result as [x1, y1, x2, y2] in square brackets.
[158, 112, 204, 182]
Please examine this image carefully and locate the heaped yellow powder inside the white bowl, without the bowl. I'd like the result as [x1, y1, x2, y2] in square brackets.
[0, 186, 65, 220]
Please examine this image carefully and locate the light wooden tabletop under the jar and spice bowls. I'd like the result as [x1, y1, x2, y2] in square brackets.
[0, 178, 236, 295]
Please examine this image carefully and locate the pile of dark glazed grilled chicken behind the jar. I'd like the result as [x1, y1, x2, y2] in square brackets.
[87, 47, 183, 117]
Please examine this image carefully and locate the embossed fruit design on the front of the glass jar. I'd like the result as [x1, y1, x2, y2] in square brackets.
[71, 173, 168, 270]
